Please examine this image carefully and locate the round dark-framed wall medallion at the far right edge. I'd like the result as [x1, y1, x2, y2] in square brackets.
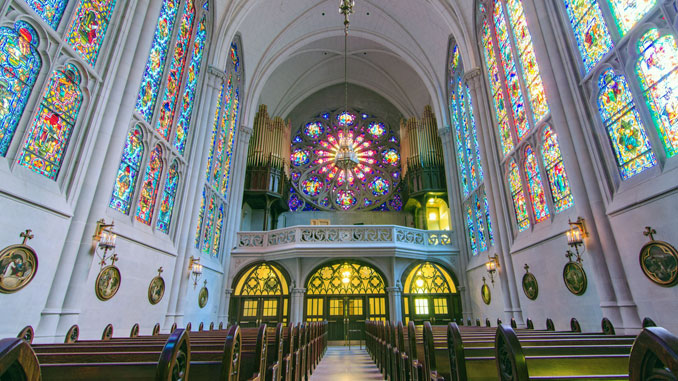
[640, 241, 678, 287]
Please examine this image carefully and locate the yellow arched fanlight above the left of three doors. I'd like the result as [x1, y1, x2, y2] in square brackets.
[233, 262, 289, 296]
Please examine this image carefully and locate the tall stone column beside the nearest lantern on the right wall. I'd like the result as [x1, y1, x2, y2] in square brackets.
[525, 1, 640, 329]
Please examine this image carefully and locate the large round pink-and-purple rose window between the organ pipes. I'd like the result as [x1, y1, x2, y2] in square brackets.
[288, 110, 402, 211]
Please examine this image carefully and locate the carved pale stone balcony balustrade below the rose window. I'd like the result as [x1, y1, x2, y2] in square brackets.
[234, 225, 458, 254]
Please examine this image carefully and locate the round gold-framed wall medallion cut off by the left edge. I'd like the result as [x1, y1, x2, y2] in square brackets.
[0, 245, 38, 294]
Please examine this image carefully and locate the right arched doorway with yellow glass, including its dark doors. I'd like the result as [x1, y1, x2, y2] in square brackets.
[403, 262, 462, 324]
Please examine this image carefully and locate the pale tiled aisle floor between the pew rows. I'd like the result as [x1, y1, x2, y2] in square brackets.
[311, 347, 384, 381]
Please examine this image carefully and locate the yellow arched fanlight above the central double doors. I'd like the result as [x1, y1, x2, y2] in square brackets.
[306, 262, 386, 295]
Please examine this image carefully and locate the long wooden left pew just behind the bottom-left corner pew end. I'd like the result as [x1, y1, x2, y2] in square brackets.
[34, 330, 191, 381]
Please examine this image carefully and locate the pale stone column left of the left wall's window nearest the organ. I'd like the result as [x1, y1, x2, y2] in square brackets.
[171, 67, 228, 329]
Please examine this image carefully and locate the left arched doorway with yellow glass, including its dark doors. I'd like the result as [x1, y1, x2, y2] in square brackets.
[230, 262, 290, 327]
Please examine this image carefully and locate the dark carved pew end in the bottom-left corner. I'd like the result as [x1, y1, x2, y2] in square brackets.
[0, 336, 41, 381]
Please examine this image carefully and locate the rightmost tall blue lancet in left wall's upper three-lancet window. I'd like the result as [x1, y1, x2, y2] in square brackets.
[174, 16, 207, 155]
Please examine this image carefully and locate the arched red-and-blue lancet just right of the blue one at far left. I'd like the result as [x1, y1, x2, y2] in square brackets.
[18, 64, 82, 180]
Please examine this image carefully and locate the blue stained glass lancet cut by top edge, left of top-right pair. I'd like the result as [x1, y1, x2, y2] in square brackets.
[563, 0, 614, 73]
